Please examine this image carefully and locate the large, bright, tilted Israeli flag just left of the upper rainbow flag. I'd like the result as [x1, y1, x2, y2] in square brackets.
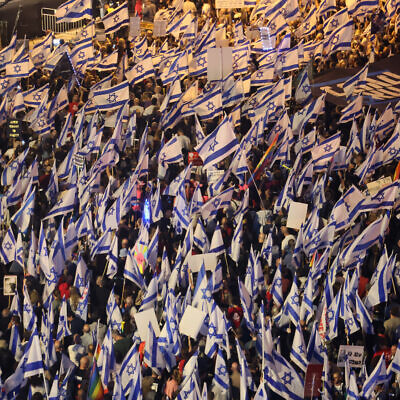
[196, 117, 239, 169]
